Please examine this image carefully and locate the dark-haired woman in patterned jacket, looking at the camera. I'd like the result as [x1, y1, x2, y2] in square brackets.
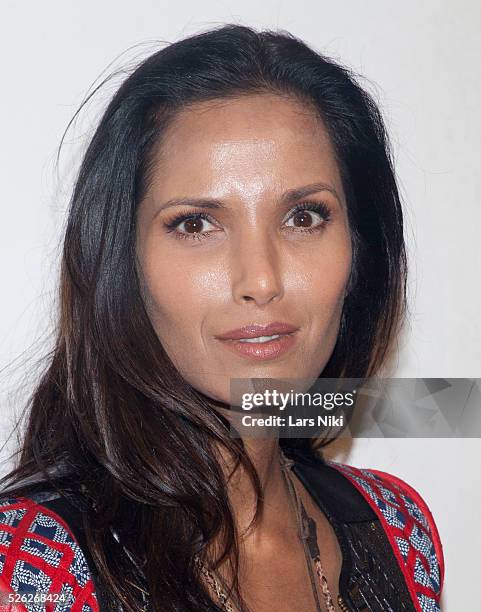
[0, 25, 444, 612]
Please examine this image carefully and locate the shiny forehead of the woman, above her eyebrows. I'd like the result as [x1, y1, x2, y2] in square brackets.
[146, 94, 342, 197]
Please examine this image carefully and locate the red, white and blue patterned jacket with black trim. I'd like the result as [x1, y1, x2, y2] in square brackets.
[0, 460, 444, 612]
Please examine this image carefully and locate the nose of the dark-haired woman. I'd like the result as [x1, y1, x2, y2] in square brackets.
[230, 231, 284, 306]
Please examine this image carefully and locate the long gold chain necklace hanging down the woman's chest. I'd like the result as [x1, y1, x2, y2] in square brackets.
[194, 450, 335, 612]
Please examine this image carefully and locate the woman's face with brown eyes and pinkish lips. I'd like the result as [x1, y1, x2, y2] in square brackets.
[137, 94, 352, 403]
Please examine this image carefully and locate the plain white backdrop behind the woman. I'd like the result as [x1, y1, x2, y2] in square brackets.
[0, 0, 481, 612]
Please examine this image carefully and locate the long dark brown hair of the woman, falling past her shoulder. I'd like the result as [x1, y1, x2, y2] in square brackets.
[2, 25, 406, 612]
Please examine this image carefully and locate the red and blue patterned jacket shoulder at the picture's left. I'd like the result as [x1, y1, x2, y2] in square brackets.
[0, 497, 99, 612]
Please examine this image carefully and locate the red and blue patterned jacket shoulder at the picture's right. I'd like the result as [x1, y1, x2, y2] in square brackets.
[327, 461, 444, 610]
